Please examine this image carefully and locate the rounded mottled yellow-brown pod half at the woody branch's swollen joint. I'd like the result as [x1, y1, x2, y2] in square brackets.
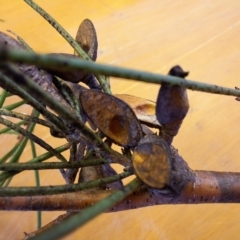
[132, 135, 172, 188]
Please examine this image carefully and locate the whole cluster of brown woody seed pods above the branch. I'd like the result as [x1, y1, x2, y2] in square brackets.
[0, 19, 189, 189]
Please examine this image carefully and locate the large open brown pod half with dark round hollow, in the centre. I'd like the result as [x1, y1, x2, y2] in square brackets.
[80, 90, 142, 147]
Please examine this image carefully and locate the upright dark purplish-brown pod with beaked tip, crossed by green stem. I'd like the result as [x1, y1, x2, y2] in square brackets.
[156, 66, 189, 144]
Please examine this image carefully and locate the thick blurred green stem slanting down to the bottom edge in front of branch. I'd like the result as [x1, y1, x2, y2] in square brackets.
[31, 179, 142, 240]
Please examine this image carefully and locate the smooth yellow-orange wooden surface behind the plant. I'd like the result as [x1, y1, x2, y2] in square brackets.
[0, 0, 240, 240]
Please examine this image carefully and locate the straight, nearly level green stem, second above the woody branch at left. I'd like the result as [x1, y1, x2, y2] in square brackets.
[0, 158, 109, 172]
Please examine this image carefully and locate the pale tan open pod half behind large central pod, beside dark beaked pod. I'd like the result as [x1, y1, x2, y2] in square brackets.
[114, 94, 161, 128]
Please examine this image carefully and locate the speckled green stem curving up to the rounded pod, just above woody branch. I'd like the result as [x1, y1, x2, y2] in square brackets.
[0, 171, 132, 197]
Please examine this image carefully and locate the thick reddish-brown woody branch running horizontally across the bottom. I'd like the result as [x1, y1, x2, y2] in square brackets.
[0, 171, 240, 212]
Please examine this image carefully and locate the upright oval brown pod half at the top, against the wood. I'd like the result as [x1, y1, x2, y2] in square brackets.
[75, 19, 98, 61]
